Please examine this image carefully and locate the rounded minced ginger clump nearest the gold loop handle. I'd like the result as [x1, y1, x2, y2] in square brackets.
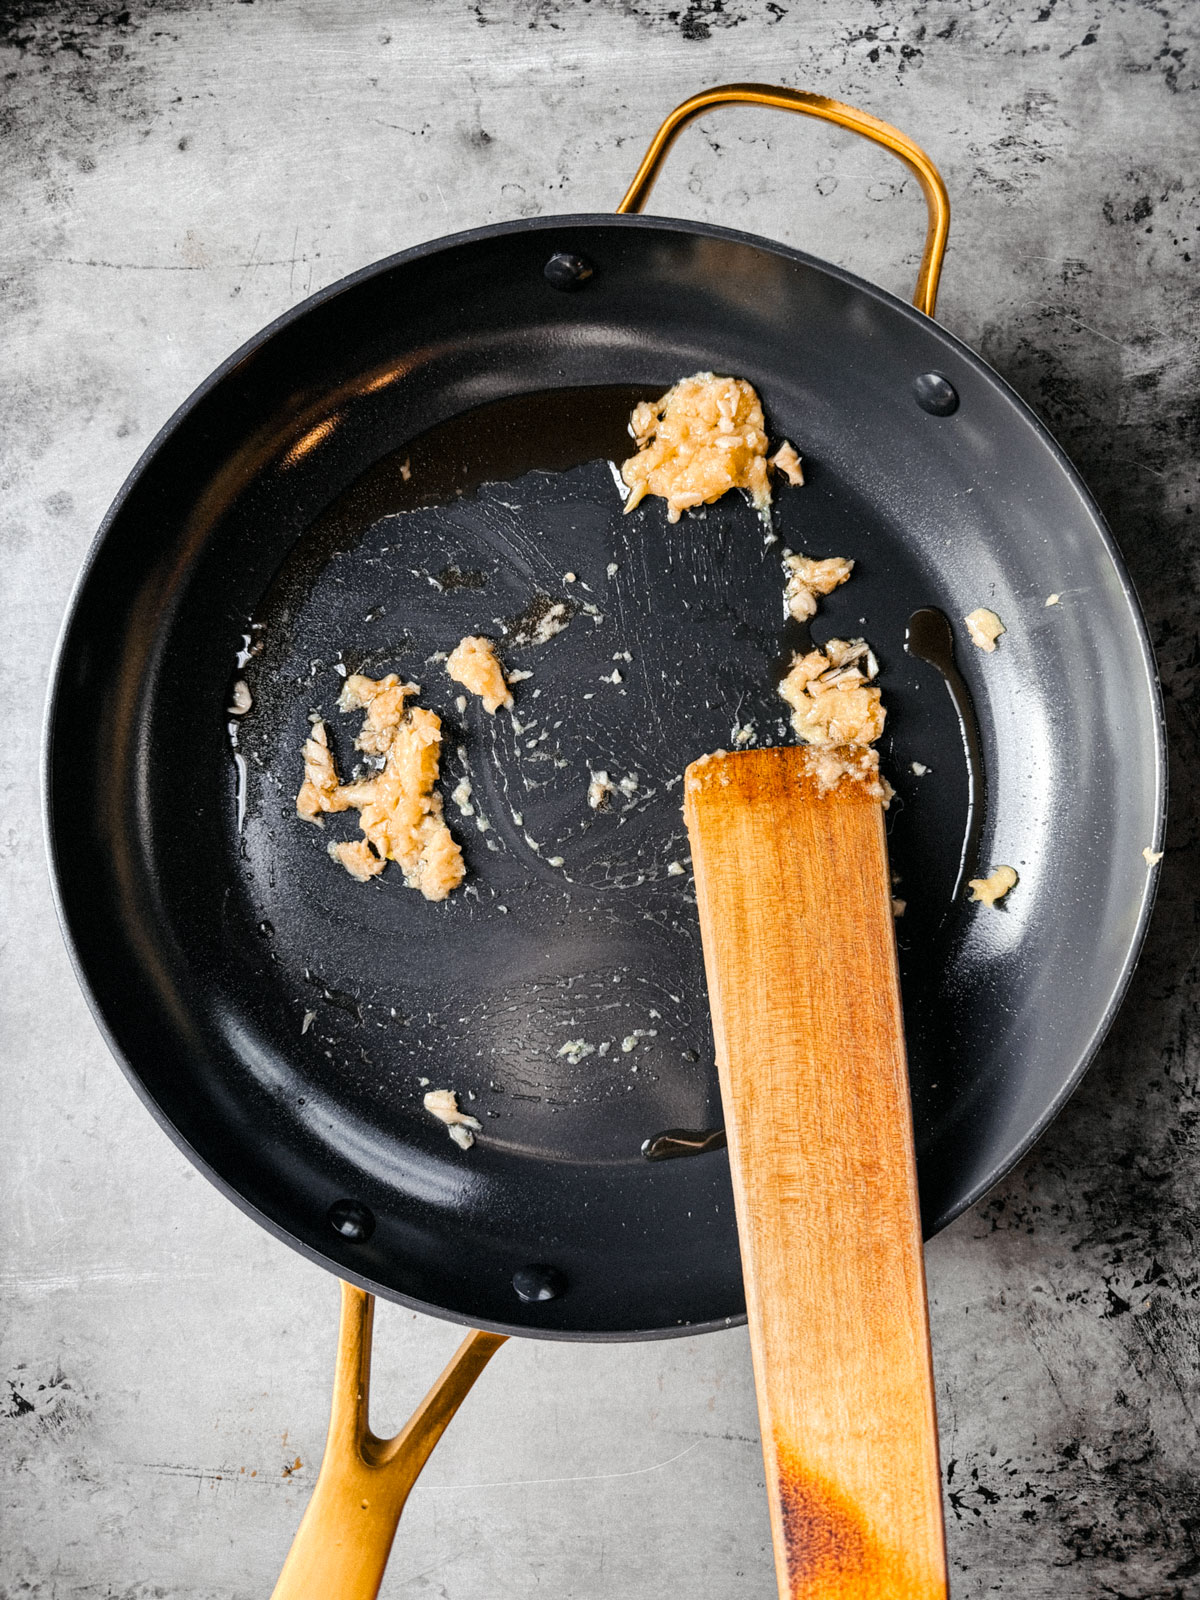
[621, 373, 803, 522]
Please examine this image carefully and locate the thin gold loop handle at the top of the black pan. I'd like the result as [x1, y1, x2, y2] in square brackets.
[616, 83, 950, 317]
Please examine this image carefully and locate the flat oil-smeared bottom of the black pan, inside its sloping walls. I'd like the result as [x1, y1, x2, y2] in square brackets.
[232, 378, 966, 1181]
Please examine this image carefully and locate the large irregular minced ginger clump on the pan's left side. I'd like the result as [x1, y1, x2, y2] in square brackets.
[296, 672, 466, 901]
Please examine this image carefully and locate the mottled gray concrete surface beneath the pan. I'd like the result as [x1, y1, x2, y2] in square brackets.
[0, 0, 1200, 1600]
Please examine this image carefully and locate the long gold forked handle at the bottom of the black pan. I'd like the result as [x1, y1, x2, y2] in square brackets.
[272, 1283, 504, 1600]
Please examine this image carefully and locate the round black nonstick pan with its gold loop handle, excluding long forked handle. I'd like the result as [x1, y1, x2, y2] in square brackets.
[46, 85, 1165, 1338]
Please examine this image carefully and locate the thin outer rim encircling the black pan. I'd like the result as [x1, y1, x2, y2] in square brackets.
[40, 211, 1168, 1342]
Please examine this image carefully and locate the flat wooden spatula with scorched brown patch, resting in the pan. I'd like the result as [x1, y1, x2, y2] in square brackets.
[683, 747, 947, 1600]
